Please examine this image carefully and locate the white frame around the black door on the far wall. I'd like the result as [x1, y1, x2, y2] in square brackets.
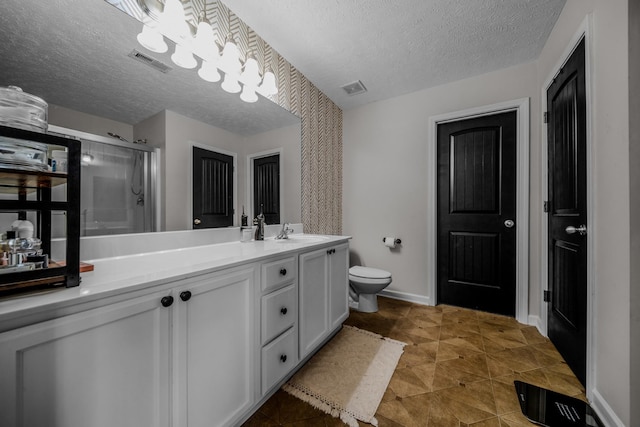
[427, 98, 530, 324]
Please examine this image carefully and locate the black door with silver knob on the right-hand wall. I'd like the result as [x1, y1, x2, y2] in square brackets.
[546, 40, 587, 384]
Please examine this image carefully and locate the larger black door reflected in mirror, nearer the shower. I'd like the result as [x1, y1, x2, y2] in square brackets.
[193, 147, 234, 228]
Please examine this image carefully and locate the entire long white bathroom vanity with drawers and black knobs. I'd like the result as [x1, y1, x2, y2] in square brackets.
[0, 237, 349, 427]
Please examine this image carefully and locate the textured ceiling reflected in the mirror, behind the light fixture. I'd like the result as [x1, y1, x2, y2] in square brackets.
[0, 0, 299, 135]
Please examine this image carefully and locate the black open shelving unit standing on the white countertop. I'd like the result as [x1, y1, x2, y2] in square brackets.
[0, 122, 81, 293]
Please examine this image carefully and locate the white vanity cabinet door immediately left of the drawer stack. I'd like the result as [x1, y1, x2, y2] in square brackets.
[173, 268, 260, 427]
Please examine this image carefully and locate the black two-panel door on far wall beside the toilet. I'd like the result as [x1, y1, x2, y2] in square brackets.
[437, 111, 517, 316]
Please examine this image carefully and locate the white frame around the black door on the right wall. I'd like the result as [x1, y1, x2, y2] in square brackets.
[539, 15, 597, 401]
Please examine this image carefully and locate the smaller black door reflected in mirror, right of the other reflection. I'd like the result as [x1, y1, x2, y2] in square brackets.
[253, 154, 280, 224]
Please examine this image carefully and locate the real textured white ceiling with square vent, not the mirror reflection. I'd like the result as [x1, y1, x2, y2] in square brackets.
[223, 0, 565, 109]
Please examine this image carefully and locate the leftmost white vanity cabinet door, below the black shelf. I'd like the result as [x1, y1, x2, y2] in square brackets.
[0, 294, 170, 427]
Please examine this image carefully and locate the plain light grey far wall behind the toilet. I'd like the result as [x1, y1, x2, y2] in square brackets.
[343, 63, 539, 304]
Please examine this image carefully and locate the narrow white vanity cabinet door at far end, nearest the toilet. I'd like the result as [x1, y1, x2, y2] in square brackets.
[329, 244, 349, 330]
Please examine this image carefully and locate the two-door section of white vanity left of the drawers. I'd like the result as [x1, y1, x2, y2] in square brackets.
[0, 264, 259, 427]
